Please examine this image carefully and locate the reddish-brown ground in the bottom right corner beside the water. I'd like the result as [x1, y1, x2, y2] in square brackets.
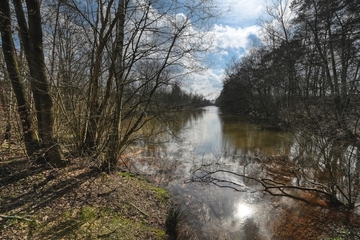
[271, 197, 360, 240]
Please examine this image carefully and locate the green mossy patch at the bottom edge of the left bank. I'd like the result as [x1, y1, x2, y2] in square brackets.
[36, 206, 166, 240]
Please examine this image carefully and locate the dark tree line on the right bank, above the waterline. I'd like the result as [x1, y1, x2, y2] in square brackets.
[217, 0, 360, 135]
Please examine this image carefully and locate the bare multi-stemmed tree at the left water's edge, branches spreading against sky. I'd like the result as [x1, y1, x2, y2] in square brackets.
[50, 0, 218, 170]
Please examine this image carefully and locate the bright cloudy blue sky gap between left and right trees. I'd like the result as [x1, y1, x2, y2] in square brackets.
[184, 0, 266, 100]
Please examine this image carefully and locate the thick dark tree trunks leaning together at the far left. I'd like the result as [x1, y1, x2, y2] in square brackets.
[1, 0, 65, 166]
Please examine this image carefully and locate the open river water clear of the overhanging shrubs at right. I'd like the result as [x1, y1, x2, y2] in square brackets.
[137, 107, 294, 239]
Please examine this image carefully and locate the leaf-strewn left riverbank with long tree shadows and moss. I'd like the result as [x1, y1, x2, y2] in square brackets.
[0, 146, 170, 239]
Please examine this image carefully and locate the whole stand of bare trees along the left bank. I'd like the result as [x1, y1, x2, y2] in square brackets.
[0, 0, 217, 171]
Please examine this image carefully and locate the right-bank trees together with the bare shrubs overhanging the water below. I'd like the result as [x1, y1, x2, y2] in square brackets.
[217, 0, 360, 209]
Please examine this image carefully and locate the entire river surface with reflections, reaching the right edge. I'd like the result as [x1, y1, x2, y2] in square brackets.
[133, 107, 360, 240]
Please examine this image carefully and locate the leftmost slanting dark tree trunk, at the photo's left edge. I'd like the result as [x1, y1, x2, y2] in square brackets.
[0, 0, 38, 156]
